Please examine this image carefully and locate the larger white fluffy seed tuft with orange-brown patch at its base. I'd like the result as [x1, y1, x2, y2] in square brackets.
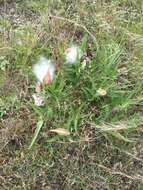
[33, 56, 55, 84]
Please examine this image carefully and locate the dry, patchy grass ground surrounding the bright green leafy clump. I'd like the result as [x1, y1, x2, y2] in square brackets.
[0, 0, 143, 190]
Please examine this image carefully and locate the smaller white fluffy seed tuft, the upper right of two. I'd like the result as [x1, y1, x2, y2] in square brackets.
[65, 45, 83, 64]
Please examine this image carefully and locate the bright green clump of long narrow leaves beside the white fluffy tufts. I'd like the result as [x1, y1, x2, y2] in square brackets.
[28, 36, 135, 147]
